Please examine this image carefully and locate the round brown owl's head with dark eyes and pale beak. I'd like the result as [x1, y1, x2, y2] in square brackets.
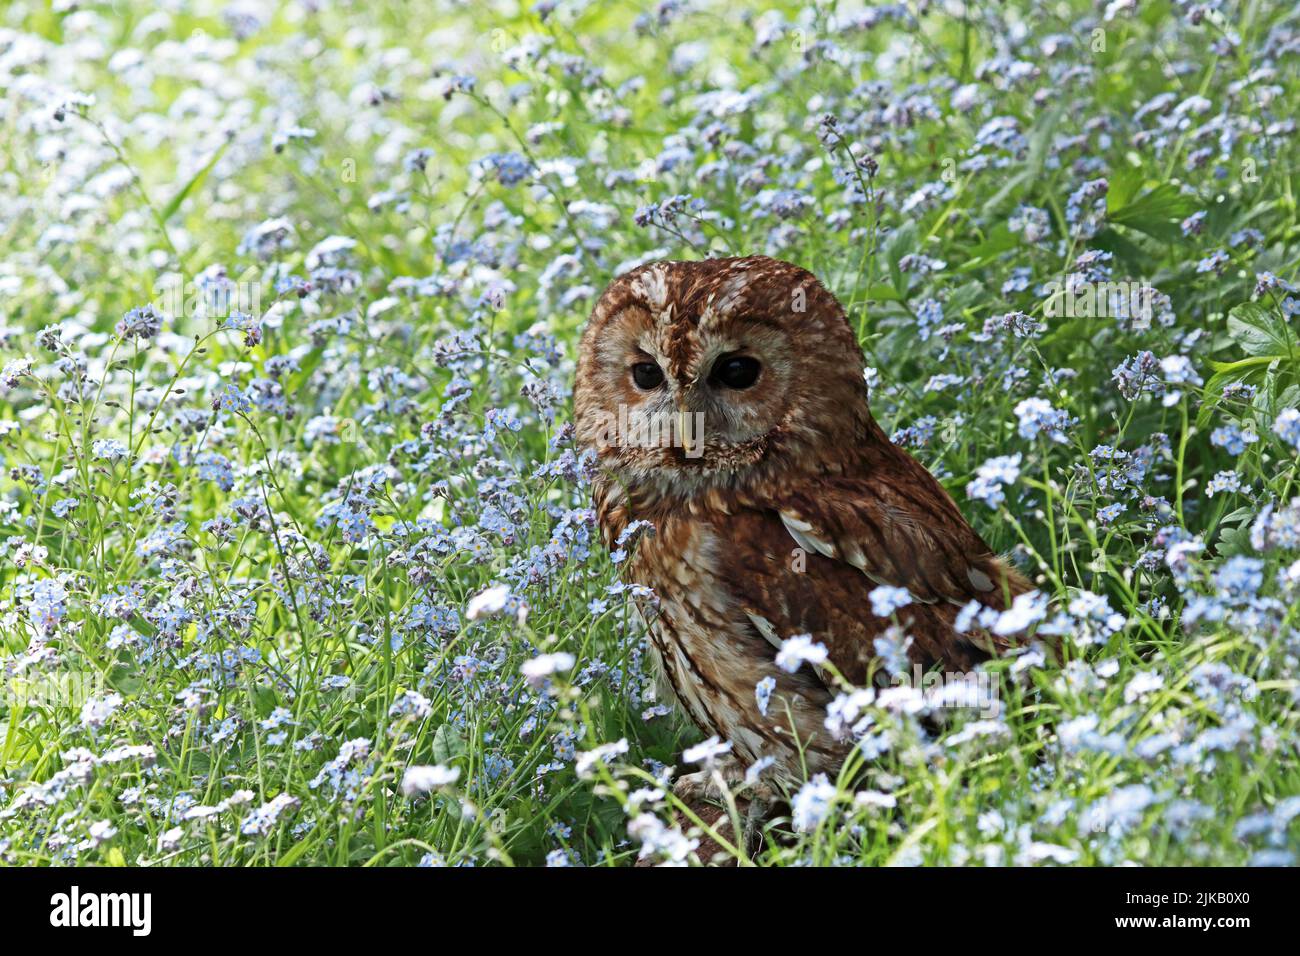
[575, 256, 870, 494]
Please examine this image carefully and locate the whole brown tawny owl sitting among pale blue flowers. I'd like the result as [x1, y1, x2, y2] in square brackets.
[575, 256, 1030, 782]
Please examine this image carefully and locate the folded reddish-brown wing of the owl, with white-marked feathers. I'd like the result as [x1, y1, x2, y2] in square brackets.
[719, 462, 1031, 689]
